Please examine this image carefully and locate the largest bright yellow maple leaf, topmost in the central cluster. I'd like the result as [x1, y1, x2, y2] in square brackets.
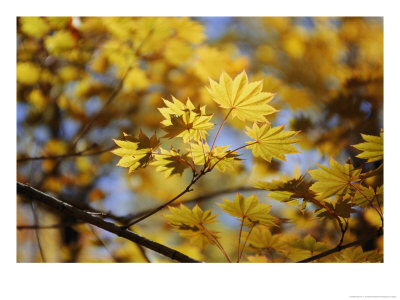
[208, 71, 277, 122]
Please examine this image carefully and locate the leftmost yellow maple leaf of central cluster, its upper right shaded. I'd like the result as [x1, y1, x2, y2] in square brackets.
[111, 131, 160, 173]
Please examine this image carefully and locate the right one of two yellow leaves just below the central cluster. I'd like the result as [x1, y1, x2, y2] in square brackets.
[217, 193, 276, 227]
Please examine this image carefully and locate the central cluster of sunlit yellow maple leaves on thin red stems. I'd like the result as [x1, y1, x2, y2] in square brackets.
[112, 71, 299, 177]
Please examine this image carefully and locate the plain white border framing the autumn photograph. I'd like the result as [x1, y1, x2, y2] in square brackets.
[0, 0, 400, 300]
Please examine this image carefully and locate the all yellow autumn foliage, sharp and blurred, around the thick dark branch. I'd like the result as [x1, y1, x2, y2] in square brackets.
[17, 17, 384, 263]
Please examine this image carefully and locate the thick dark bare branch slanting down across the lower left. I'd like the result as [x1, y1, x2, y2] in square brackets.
[17, 182, 199, 262]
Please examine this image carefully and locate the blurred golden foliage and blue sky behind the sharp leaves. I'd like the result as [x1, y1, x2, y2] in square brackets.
[17, 17, 383, 262]
